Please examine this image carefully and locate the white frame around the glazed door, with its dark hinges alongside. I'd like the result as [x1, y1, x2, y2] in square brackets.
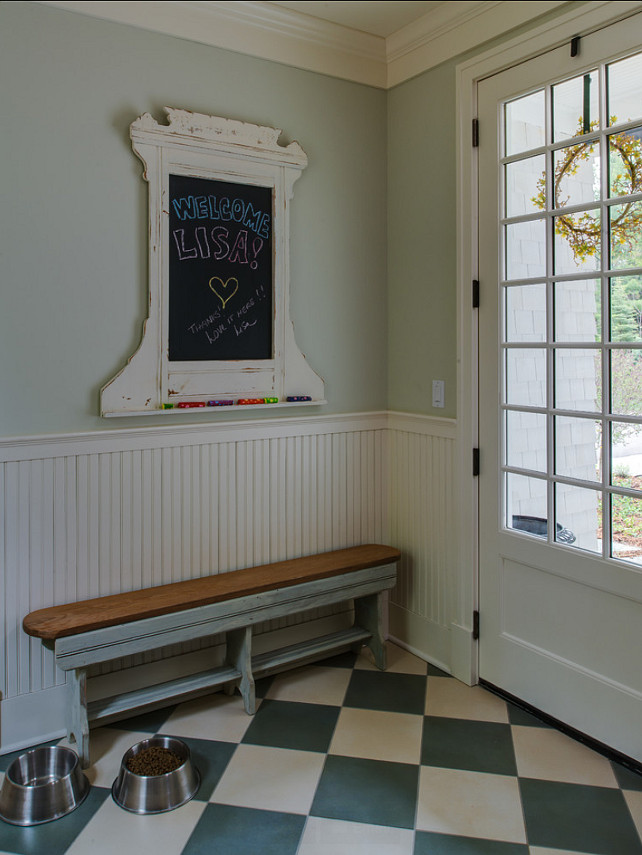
[451, 0, 642, 685]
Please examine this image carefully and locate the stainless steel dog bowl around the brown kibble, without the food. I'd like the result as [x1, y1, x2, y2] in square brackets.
[111, 736, 200, 814]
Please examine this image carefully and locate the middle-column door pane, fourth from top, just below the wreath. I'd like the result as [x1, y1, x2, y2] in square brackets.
[554, 279, 602, 343]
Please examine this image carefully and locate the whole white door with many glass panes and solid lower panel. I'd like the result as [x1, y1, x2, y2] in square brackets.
[478, 16, 642, 761]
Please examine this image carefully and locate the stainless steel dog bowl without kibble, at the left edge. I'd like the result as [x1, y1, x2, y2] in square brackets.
[0, 745, 90, 825]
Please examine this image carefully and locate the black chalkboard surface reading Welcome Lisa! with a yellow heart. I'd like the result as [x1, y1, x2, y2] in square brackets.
[168, 174, 273, 362]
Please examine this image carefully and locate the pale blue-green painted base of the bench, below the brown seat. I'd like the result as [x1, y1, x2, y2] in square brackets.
[48, 564, 396, 768]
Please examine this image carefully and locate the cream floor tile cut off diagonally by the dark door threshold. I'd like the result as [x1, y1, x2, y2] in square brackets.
[512, 725, 618, 787]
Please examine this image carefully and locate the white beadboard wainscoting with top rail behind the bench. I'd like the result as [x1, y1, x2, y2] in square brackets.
[0, 413, 456, 752]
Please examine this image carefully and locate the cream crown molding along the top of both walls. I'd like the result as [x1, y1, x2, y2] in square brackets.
[34, 0, 568, 89]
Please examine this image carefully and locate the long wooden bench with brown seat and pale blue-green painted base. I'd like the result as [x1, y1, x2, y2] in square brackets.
[23, 544, 400, 768]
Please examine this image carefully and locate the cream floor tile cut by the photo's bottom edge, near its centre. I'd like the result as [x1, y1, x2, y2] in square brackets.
[297, 816, 414, 855]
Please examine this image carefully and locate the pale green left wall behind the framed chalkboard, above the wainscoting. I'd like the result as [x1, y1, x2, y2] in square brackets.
[0, 2, 387, 436]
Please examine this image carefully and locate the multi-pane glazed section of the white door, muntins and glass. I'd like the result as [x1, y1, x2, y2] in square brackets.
[500, 54, 642, 565]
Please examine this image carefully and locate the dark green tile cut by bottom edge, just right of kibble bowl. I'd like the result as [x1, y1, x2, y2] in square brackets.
[182, 804, 305, 855]
